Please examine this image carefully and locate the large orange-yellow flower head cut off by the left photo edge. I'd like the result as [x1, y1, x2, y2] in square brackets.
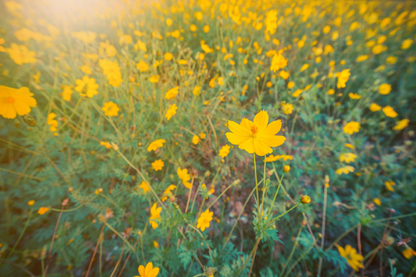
[0, 86, 37, 119]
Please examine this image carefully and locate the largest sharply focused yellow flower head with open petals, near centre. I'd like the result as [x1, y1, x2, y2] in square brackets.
[226, 111, 286, 156]
